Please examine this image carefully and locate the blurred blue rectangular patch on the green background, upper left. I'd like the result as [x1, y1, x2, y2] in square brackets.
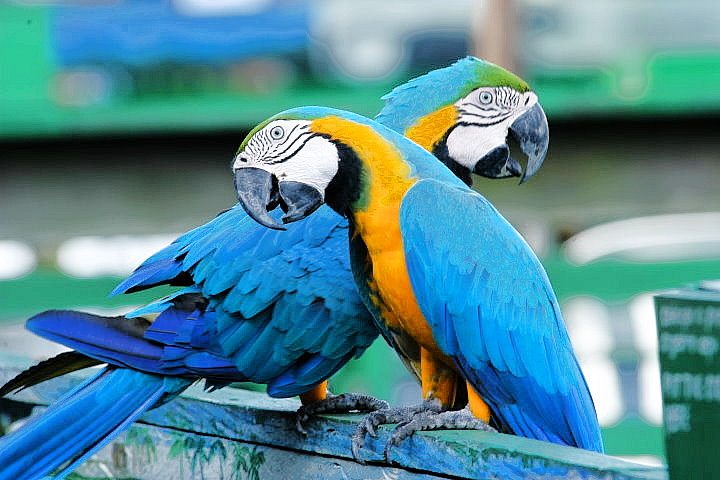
[50, 0, 308, 105]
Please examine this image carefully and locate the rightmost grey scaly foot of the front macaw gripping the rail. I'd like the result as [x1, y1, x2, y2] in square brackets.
[385, 407, 497, 459]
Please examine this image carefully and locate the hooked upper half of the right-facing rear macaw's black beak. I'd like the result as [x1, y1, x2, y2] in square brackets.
[510, 103, 550, 183]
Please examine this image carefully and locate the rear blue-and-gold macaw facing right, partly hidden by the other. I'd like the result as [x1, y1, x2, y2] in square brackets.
[0, 58, 547, 479]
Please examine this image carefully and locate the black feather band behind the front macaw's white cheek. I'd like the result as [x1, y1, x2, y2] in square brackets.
[325, 137, 364, 217]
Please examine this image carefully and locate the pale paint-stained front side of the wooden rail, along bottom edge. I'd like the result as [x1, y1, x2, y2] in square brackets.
[64, 424, 438, 480]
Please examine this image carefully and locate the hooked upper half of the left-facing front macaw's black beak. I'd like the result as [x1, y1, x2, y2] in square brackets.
[234, 167, 285, 230]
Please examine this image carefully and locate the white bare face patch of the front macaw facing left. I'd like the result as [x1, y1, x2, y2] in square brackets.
[233, 120, 340, 198]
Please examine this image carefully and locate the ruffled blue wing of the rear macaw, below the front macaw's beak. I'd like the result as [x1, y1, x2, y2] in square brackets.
[113, 205, 377, 396]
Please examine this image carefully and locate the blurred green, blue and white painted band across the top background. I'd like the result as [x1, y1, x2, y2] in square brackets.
[0, 0, 720, 137]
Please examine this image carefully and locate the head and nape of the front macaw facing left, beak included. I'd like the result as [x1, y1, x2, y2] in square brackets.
[233, 107, 450, 230]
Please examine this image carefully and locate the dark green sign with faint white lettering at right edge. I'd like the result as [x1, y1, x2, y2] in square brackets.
[655, 289, 720, 479]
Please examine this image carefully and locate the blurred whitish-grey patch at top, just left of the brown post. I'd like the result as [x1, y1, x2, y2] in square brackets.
[309, 0, 476, 82]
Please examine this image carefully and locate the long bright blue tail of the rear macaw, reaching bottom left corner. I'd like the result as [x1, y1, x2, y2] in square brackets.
[0, 367, 192, 480]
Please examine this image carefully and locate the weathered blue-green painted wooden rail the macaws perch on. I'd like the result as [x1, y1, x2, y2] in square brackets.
[0, 355, 666, 480]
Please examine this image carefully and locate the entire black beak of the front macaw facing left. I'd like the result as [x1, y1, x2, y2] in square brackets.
[234, 167, 323, 230]
